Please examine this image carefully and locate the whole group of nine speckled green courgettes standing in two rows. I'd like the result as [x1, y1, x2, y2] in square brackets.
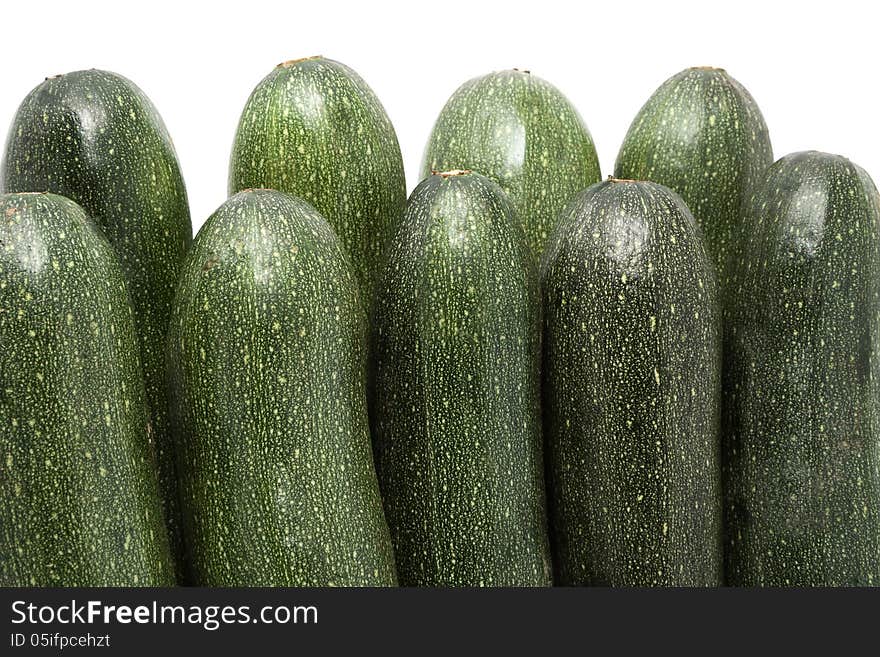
[0, 58, 880, 586]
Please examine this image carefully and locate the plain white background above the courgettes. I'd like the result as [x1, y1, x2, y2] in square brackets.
[0, 0, 880, 229]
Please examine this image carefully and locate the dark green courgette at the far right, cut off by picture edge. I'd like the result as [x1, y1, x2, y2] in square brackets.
[725, 152, 880, 586]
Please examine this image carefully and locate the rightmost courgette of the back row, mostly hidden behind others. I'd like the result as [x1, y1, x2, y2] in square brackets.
[614, 67, 773, 282]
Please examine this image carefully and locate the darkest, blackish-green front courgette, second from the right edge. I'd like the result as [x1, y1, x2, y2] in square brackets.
[542, 181, 722, 586]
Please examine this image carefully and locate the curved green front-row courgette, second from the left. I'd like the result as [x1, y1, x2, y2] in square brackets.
[167, 190, 395, 586]
